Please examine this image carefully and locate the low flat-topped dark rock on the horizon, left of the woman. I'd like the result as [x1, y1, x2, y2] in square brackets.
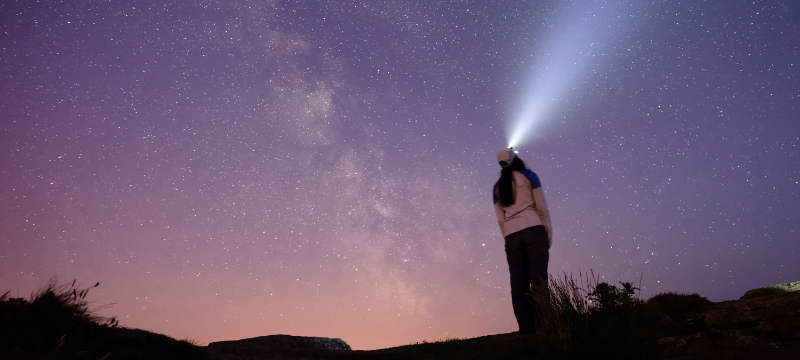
[208, 335, 352, 360]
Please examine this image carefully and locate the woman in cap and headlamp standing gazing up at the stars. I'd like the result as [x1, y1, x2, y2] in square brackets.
[494, 148, 553, 334]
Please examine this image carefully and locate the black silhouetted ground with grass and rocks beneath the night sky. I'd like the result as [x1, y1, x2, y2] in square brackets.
[0, 276, 800, 360]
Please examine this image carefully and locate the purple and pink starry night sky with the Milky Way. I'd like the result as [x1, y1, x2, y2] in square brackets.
[0, 0, 800, 349]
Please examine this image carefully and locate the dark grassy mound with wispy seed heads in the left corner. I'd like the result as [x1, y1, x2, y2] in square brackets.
[0, 279, 207, 360]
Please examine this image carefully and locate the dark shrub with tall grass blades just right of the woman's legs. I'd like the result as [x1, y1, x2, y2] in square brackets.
[533, 273, 660, 359]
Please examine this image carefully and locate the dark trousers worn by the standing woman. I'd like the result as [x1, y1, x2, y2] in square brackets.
[506, 225, 550, 333]
